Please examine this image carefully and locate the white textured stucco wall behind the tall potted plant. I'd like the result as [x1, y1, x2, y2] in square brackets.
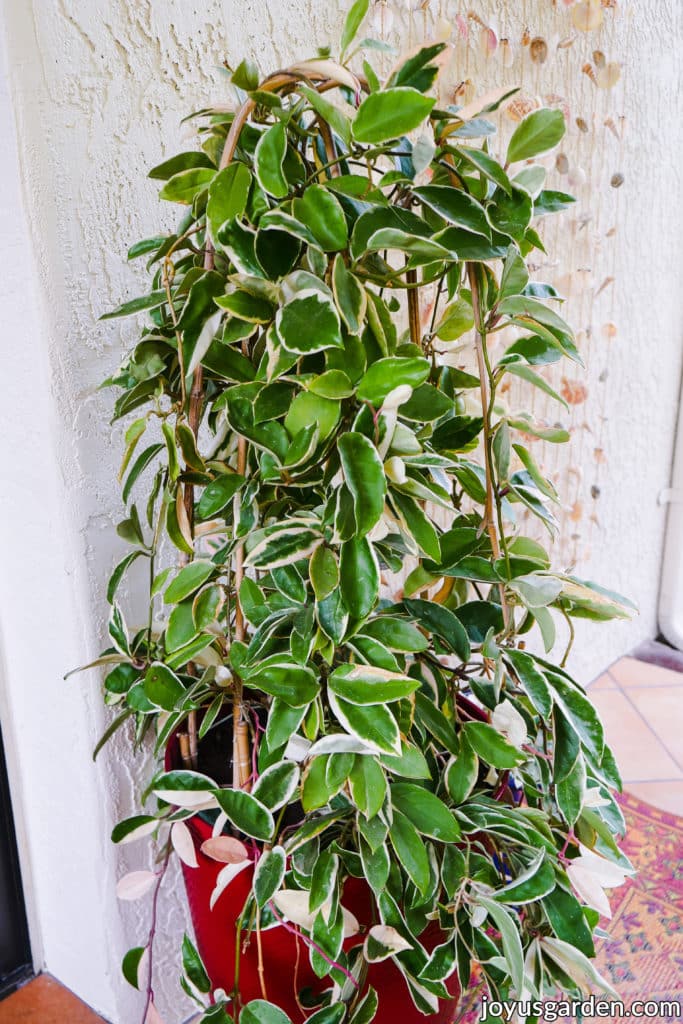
[0, 0, 683, 1024]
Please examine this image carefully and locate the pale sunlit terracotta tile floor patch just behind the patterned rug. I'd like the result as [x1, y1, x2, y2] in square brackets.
[589, 642, 683, 817]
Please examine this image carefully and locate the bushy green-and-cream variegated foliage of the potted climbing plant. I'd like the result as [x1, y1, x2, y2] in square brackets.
[83, 0, 630, 1024]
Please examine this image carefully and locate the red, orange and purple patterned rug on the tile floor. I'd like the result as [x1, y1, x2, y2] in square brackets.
[456, 794, 683, 1024]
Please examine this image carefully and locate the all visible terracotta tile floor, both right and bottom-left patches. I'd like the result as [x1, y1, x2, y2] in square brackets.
[0, 642, 683, 1024]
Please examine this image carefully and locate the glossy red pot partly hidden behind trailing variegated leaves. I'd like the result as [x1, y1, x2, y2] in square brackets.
[166, 740, 460, 1024]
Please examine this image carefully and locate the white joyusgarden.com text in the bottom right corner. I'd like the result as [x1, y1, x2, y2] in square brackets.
[479, 995, 682, 1024]
